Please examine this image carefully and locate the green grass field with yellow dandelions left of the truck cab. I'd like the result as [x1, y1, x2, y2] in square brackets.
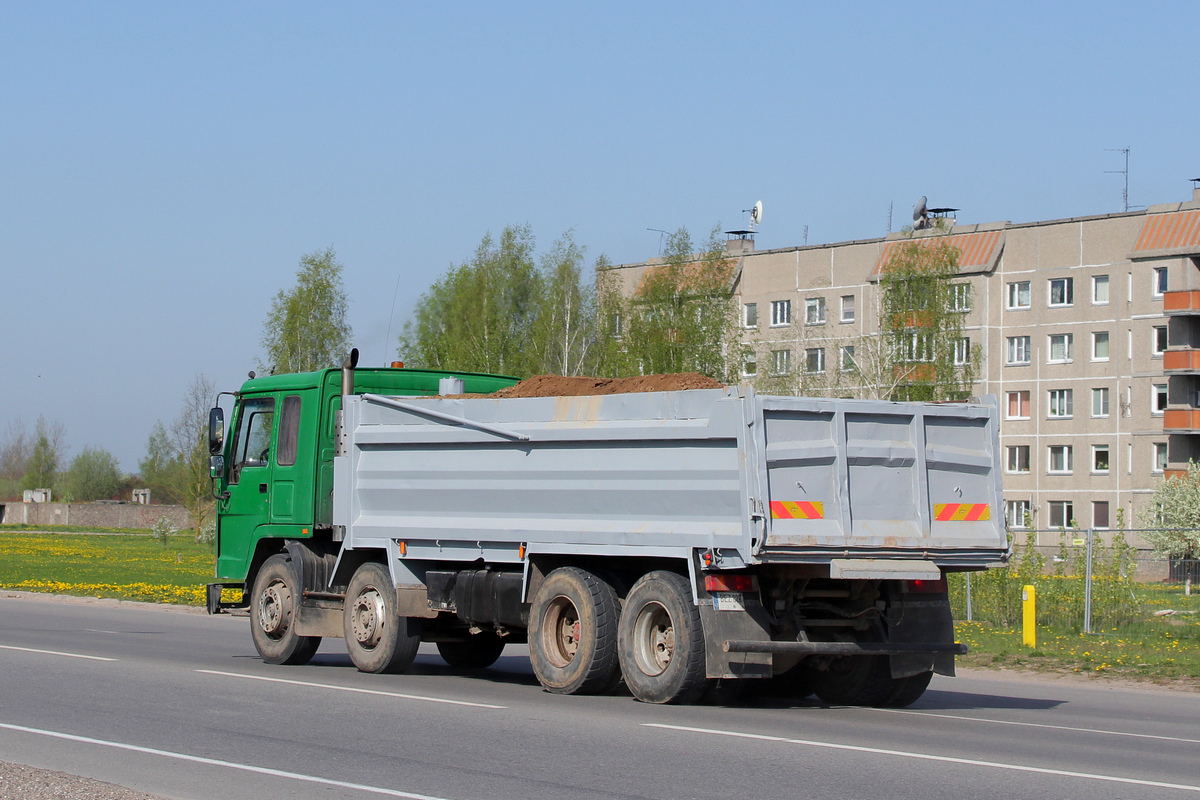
[0, 529, 214, 606]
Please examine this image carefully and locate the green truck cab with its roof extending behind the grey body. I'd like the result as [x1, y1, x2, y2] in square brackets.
[209, 351, 518, 610]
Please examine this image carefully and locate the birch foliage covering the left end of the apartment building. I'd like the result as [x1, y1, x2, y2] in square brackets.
[596, 228, 744, 383]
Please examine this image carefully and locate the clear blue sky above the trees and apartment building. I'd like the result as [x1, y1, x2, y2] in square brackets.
[0, 0, 1200, 471]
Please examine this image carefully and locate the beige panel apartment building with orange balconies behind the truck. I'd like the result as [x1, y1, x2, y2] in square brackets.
[610, 188, 1200, 537]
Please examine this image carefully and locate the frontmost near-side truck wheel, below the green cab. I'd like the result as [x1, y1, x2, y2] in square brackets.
[250, 553, 320, 664]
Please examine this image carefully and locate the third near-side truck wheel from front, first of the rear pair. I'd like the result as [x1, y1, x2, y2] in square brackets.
[529, 566, 620, 694]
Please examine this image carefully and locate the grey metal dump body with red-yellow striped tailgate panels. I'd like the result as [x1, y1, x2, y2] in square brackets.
[334, 387, 1007, 575]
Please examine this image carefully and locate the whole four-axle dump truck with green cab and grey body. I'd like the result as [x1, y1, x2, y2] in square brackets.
[208, 351, 1008, 706]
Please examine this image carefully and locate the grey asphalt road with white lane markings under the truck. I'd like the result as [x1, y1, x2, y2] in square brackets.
[0, 599, 1200, 800]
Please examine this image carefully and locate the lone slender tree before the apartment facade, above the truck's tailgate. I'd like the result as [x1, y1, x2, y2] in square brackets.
[876, 239, 974, 401]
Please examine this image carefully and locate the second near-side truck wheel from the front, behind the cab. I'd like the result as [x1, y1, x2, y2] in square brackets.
[342, 561, 421, 673]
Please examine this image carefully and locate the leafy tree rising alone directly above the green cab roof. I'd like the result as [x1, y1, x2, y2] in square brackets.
[263, 247, 350, 374]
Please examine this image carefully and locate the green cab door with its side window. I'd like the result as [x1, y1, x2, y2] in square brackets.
[217, 397, 276, 579]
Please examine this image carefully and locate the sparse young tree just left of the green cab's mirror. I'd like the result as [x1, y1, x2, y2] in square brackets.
[138, 374, 216, 533]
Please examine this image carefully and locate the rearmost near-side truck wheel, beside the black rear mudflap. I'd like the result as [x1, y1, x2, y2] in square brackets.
[619, 571, 710, 703]
